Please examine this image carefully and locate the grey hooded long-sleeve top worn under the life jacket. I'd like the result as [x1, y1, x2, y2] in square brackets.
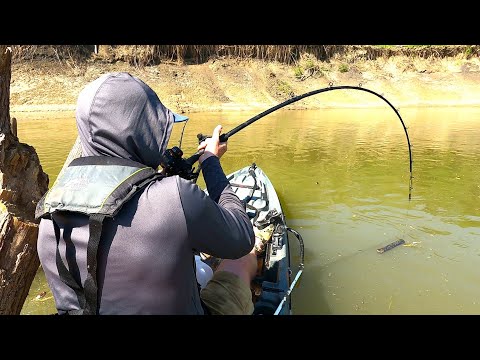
[38, 73, 254, 314]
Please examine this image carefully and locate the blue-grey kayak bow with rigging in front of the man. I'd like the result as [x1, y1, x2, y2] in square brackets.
[204, 163, 303, 315]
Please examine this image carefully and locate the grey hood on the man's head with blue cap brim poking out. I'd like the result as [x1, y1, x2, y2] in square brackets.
[76, 72, 188, 169]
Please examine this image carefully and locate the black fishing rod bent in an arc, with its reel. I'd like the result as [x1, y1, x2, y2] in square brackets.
[161, 83, 413, 200]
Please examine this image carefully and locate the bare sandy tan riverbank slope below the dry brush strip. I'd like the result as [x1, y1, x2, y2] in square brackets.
[10, 48, 480, 113]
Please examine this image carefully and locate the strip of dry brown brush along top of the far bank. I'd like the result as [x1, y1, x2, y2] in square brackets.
[13, 45, 480, 66]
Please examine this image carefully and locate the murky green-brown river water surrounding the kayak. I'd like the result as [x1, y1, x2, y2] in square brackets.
[16, 108, 480, 314]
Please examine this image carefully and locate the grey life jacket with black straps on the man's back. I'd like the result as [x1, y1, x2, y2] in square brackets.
[35, 156, 164, 315]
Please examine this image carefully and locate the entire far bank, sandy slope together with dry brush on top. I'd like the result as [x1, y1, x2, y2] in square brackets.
[10, 45, 480, 113]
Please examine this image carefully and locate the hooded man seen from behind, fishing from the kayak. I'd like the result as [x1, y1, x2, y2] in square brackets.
[37, 73, 256, 314]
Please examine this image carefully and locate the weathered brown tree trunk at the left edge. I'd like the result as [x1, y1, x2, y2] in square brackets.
[0, 45, 48, 315]
